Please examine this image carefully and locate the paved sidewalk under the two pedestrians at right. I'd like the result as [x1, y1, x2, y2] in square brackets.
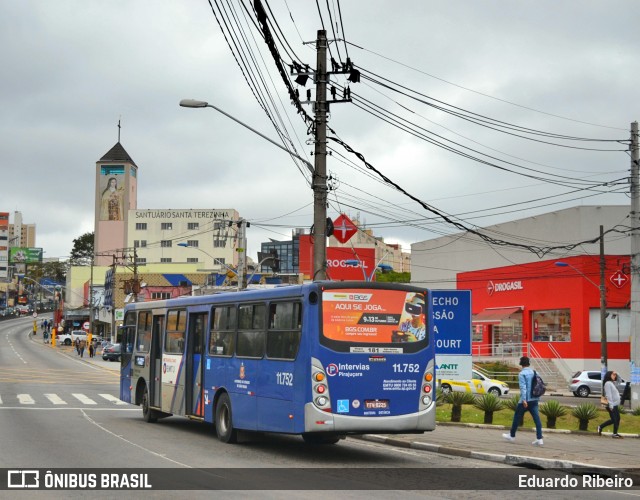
[362, 422, 640, 471]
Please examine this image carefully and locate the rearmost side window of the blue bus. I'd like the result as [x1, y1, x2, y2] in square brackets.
[267, 302, 302, 360]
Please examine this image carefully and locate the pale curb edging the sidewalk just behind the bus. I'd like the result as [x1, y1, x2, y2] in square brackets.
[356, 434, 610, 470]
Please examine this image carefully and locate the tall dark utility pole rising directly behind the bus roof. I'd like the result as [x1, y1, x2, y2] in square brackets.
[312, 30, 328, 281]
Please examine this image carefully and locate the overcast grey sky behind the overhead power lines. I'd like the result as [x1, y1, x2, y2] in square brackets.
[0, 0, 640, 259]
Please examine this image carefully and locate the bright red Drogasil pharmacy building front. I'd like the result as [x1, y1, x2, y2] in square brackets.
[457, 255, 631, 379]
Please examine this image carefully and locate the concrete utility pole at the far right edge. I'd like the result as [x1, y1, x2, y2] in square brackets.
[629, 122, 640, 409]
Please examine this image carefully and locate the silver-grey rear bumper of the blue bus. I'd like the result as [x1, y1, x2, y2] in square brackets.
[304, 402, 436, 434]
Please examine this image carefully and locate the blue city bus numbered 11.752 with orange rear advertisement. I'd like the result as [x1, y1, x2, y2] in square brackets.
[119, 281, 435, 444]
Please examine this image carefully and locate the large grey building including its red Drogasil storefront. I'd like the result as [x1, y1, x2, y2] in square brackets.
[411, 205, 630, 378]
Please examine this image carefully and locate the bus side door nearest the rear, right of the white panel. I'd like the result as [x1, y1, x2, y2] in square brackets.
[185, 313, 209, 417]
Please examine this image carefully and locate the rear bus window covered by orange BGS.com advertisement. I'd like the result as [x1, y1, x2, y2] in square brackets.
[320, 288, 429, 353]
